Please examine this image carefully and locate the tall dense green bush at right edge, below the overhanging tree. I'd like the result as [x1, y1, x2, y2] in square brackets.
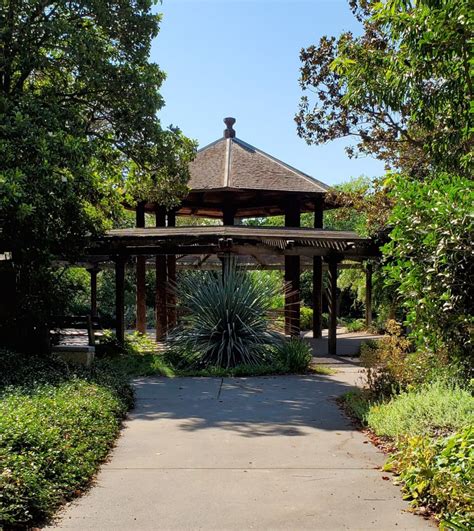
[384, 173, 474, 359]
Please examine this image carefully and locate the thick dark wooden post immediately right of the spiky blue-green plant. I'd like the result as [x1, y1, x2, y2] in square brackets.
[285, 201, 301, 337]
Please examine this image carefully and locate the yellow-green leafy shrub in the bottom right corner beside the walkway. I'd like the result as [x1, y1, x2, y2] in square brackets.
[386, 425, 474, 531]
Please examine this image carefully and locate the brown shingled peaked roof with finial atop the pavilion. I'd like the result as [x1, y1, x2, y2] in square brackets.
[188, 118, 328, 194]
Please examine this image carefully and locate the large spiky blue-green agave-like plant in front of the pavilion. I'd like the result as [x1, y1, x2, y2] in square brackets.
[168, 267, 281, 368]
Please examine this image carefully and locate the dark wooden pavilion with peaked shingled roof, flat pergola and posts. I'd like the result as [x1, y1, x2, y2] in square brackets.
[87, 118, 379, 354]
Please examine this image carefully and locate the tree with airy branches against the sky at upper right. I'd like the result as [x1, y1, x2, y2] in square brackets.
[296, 0, 473, 179]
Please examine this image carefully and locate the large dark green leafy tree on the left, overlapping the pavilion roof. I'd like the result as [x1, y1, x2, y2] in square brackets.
[0, 0, 195, 354]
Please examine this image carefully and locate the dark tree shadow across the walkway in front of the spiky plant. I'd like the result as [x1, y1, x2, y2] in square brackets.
[130, 375, 362, 437]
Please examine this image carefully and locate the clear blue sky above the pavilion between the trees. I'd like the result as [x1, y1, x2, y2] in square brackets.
[152, 0, 383, 184]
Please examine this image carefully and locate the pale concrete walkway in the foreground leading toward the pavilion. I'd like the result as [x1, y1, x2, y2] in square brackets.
[50, 364, 431, 530]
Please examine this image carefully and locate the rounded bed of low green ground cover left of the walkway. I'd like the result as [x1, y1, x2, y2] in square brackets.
[0, 351, 132, 528]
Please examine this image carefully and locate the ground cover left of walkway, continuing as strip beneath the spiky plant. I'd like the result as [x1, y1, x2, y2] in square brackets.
[0, 331, 326, 528]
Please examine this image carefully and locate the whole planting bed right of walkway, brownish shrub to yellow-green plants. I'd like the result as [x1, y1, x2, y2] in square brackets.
[343, 332, 474, 529]
